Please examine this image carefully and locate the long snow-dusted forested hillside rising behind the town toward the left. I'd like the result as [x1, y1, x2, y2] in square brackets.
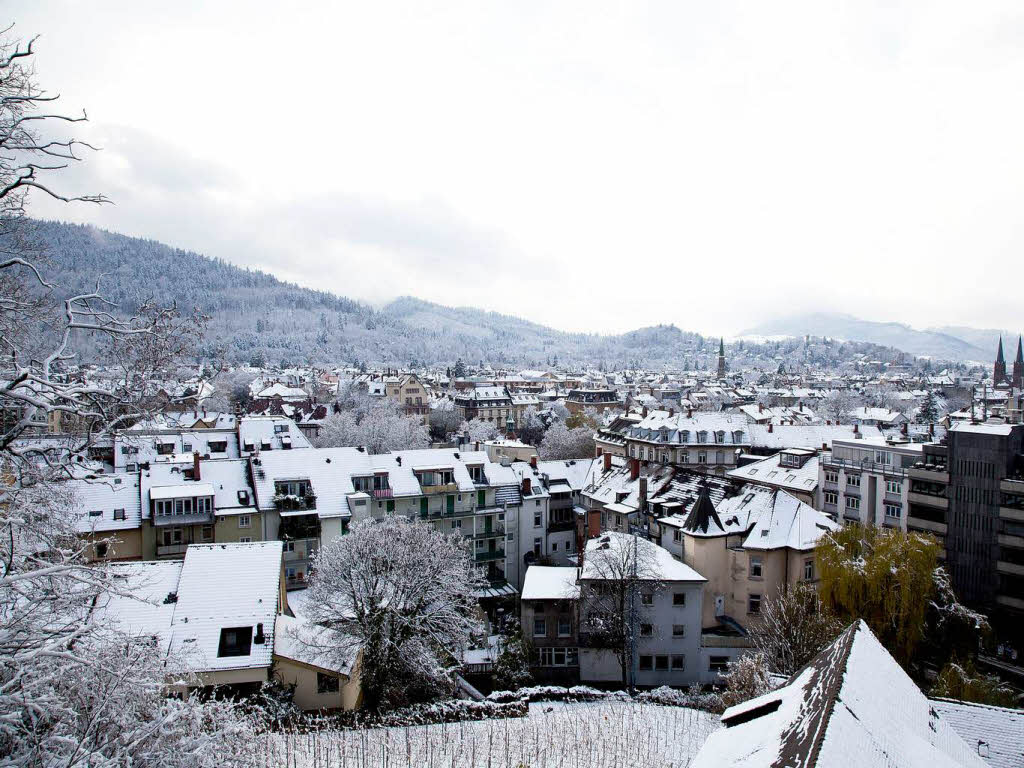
[31, 221, 913, 369]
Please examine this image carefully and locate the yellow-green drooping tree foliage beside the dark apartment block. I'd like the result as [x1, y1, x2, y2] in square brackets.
[816, 525, 939, 666]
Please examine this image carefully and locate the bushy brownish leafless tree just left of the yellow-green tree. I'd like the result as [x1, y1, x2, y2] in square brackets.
[750, 583, 843, 676]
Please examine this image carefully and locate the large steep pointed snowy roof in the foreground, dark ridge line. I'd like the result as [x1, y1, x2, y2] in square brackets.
[692, 621, 985, 768]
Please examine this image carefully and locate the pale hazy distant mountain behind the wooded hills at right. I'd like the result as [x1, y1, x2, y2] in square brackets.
[740, 312, 995, 360]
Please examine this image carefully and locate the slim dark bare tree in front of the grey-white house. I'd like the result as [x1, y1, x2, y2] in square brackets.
[580, 531, 664, 688]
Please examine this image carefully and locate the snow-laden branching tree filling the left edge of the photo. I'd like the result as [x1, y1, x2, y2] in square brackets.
[0, 33, 253, 768]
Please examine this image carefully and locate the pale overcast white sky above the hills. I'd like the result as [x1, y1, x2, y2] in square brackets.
[4, 0, 1024, 335]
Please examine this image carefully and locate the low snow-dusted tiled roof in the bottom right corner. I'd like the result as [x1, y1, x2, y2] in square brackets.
[931, 698, 1024, 768]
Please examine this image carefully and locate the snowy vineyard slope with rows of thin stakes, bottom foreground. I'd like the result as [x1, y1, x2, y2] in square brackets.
[260, 702, 719, 768]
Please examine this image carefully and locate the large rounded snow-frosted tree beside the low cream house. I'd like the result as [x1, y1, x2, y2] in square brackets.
[299, 515, 484, 710]
